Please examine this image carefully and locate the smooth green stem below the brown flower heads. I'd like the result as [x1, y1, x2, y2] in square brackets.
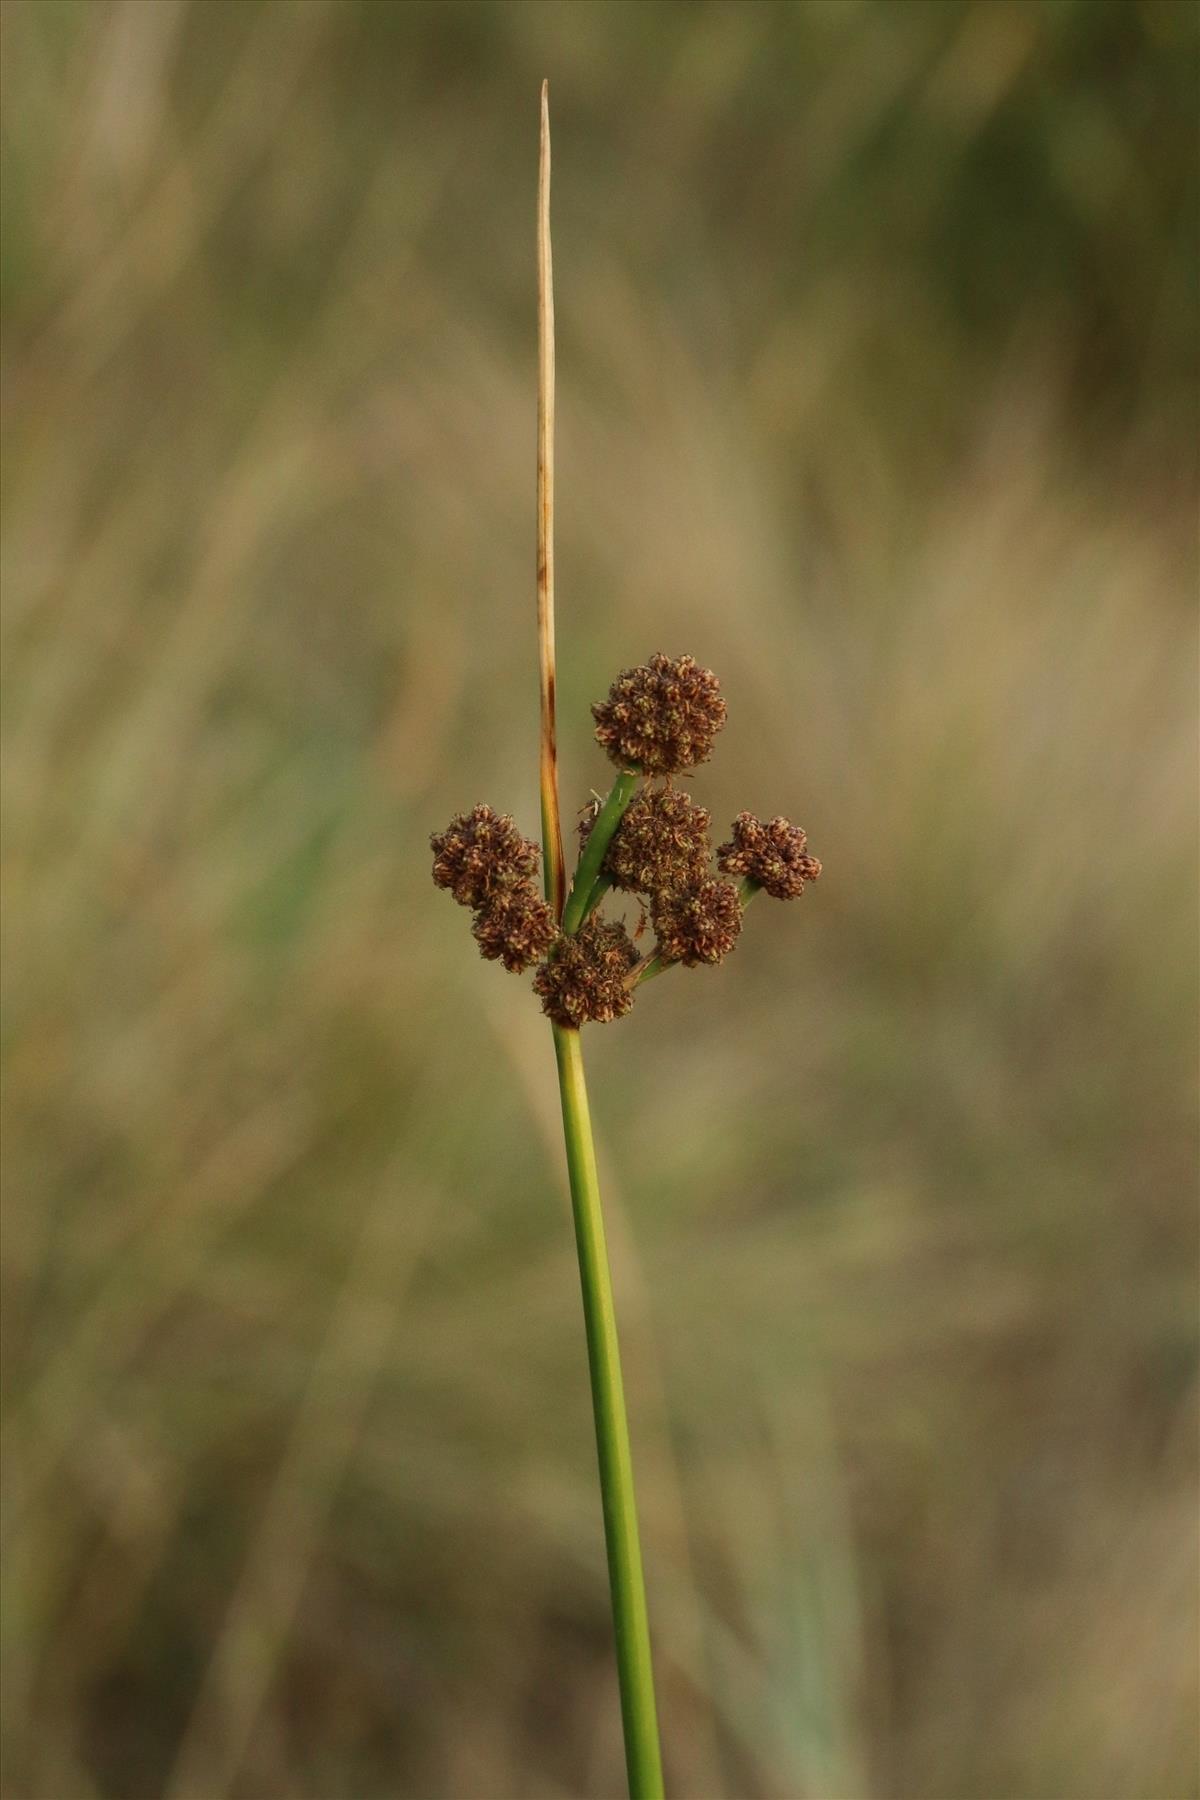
[554, 1024, 664, 1800]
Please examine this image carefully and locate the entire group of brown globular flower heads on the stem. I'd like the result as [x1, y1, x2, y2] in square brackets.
[430, 655, 820, 1030]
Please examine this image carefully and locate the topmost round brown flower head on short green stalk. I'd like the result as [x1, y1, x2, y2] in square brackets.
[592, 655, 725, 776]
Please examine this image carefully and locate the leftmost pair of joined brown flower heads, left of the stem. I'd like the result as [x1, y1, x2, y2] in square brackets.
[430, 806, 558, 974]
